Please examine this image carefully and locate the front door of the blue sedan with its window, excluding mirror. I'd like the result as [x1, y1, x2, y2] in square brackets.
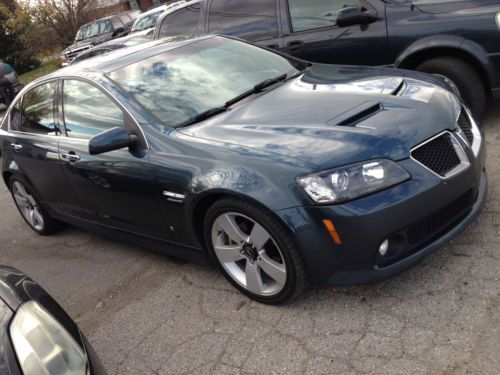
[59, 80, 170, 239]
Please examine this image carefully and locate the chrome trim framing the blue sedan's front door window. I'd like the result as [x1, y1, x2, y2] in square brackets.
[58, 76, 149, 150]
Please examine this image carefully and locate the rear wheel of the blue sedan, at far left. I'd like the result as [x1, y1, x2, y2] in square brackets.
[9, 177, 59, 235]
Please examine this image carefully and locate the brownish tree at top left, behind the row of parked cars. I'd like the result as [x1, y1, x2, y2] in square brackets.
[34, 0, 96, 47]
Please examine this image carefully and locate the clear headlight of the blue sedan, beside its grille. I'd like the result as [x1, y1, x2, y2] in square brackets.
[297, 159, 410, 203]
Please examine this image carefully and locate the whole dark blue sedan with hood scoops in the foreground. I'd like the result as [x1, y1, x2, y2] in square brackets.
[0, 37, 486, 303]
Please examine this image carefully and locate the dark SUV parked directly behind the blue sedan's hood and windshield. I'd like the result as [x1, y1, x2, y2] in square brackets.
[155, 0, 500, 114]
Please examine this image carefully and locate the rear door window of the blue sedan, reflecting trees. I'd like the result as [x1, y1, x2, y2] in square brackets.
[15, 82, 59, 135]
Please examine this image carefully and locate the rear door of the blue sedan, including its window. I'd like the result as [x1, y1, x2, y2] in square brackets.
[7, 80, 80, 215]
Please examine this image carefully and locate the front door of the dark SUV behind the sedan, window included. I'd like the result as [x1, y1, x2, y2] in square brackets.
[280, 0, 388, 65]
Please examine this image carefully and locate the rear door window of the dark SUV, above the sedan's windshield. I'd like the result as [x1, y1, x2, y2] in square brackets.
[208, 0, 278, 41]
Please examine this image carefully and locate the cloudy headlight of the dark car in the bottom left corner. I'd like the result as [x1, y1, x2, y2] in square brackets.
[10, 301, 87, 375]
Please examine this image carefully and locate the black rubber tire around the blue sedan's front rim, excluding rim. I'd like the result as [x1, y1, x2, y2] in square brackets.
[203, 199, 297, 304]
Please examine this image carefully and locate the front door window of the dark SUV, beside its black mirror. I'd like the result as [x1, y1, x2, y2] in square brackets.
[288, 0, 360, 32]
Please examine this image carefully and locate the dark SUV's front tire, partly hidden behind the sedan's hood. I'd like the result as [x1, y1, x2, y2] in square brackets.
[416, 56, 486, 118]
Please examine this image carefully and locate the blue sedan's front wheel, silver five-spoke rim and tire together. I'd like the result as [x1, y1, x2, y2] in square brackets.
[204, 198, 308, 304]
